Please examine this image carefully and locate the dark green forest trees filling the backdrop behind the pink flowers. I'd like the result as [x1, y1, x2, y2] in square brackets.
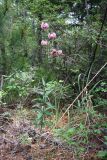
[0, 0, 107, 105]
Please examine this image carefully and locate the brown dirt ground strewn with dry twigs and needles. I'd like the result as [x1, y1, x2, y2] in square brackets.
[0, 108, 105, 160]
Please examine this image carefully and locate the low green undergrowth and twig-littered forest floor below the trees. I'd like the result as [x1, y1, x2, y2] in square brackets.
[0, 63, 107, 160]
